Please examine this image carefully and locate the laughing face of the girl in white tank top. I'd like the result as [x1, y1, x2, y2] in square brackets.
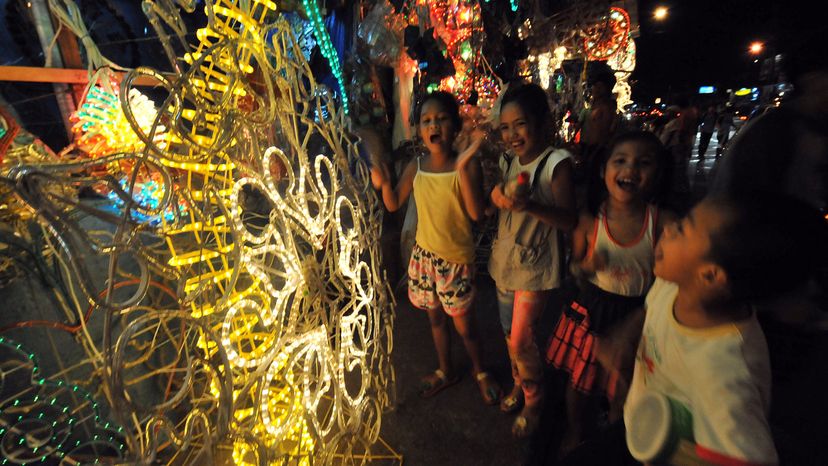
[603, 141, 657, 203]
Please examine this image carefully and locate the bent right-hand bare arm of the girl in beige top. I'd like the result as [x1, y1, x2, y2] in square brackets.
[513, 159, 578, 232]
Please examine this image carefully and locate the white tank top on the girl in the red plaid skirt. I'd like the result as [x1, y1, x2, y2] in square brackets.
[587, 206, 658, 296]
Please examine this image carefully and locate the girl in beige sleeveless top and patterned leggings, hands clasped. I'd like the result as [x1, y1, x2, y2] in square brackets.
[489, 84, 577, 437]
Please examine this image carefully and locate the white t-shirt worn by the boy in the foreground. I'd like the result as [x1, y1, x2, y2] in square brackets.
[624, 278, 778, 465]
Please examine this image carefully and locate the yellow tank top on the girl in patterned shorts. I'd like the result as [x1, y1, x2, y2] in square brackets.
[414, 159, 474, 264]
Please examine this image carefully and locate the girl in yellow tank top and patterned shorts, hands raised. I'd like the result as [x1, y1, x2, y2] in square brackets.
[371, 92, 500, 404]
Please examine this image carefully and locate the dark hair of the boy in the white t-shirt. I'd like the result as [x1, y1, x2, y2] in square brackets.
[708, 191, 828, 302]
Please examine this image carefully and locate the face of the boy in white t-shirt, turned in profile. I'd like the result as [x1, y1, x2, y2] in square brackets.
[653, 201, 724, 285]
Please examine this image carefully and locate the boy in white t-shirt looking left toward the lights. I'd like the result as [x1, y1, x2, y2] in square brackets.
[612, 192, 828, 465]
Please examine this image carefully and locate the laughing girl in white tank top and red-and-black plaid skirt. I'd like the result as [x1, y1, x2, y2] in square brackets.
[547, 131, 671, 453]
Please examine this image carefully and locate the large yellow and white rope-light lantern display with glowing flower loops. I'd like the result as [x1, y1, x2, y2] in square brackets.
[5, 0, 394, 464]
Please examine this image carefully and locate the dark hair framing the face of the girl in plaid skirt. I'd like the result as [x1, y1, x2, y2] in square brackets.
[587, 131, 673, 215]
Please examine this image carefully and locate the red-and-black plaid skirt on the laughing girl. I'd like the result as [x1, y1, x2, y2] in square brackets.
[546, 283, 644, 399]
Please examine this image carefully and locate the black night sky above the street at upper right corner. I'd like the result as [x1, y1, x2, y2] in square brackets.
[632, 0, 828, 103]
